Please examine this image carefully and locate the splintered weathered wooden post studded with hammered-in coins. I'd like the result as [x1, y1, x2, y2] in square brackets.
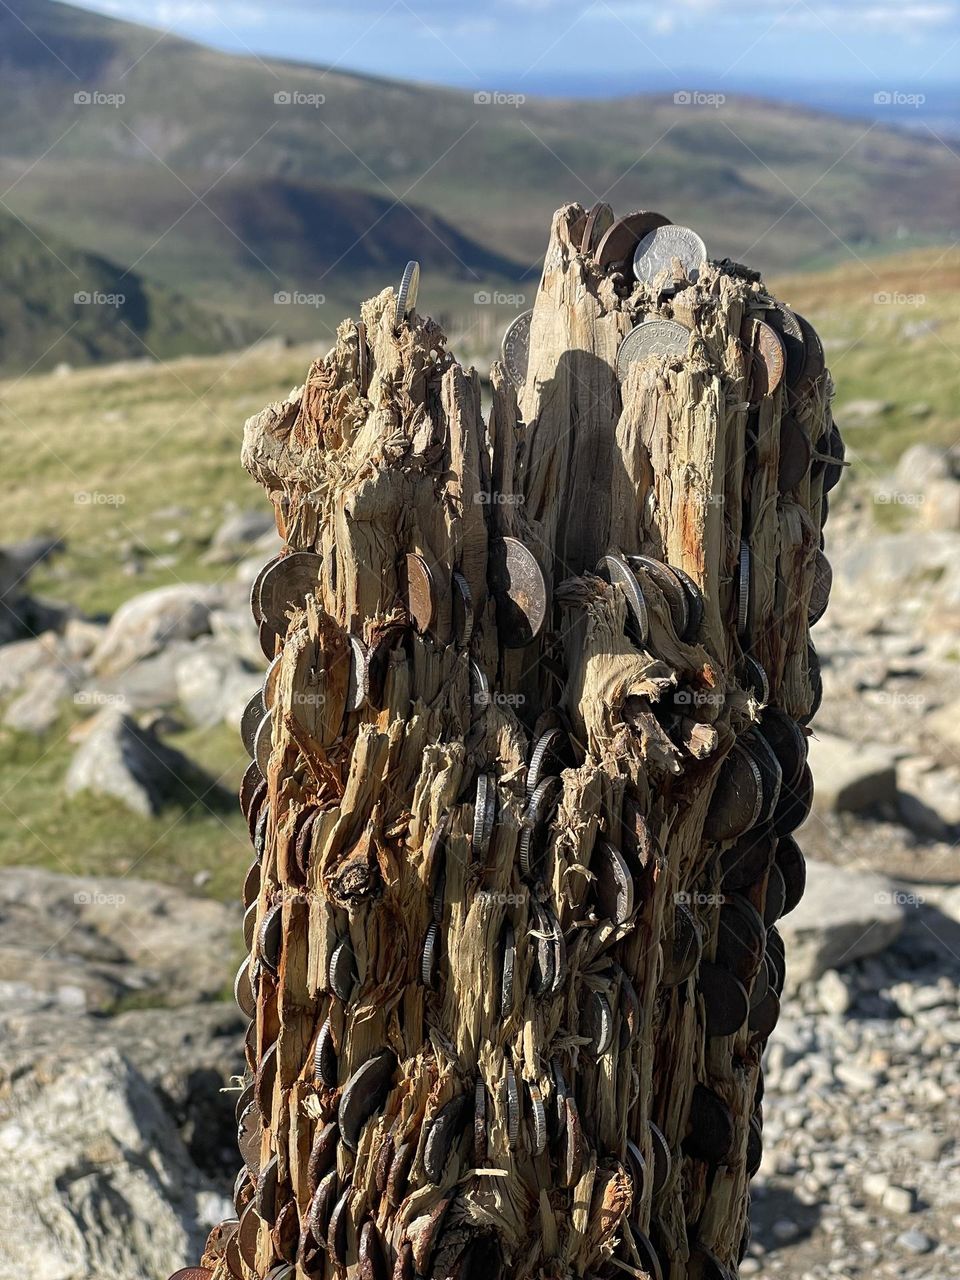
[207, 205, 838, 1280]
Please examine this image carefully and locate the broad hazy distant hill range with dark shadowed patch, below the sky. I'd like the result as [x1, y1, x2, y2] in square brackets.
[0, 0, 960, 366]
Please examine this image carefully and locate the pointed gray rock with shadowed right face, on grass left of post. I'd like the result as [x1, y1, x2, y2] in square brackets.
[64, 707, 224, 817]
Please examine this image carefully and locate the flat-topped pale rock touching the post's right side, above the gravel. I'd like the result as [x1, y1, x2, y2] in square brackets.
[777, 858, 906, 984]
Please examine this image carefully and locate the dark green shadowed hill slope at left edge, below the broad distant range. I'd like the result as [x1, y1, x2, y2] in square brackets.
[0, 211, 257, 372]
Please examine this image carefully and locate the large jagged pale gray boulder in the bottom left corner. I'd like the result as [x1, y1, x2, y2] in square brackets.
[0, 1048, 221, 1280]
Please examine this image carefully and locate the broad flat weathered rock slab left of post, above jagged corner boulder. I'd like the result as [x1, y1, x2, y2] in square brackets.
[0, 867, 239, 1015]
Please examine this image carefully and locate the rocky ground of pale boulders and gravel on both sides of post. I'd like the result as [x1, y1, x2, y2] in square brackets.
[0, 447, 960, 1280]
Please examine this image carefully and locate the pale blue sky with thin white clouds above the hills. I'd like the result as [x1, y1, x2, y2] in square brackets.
[67, 0, 960, 96]
